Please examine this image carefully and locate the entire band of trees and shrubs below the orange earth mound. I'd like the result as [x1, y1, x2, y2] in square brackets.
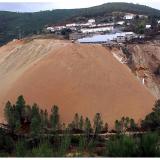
[0, 96, 160, 157]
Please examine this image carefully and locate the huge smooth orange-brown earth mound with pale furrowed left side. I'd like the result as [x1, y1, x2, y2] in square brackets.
[0, 39, 155, 127]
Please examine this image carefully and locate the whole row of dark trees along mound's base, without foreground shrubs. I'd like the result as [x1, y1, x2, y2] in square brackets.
[4, 96, 160, 136]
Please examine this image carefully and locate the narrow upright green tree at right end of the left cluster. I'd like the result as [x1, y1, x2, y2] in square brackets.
[50, 106, 60, 130]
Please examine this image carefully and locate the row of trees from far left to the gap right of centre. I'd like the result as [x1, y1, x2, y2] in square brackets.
[5, 96, 108, 136]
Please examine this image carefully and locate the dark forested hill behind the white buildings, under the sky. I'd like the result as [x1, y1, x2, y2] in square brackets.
[0, 3, 160, 45]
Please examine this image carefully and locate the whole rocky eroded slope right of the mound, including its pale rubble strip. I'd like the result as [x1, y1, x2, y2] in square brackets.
[112, 40, 160, 99]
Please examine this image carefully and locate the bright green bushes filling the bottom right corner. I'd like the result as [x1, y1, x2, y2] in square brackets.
[105, 132, 160, 157]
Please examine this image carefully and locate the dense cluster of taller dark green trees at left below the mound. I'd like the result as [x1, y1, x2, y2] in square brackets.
[4, 96, 60, 134]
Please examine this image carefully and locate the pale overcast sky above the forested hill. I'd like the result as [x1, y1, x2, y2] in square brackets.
[0, 0, 160, 12]
